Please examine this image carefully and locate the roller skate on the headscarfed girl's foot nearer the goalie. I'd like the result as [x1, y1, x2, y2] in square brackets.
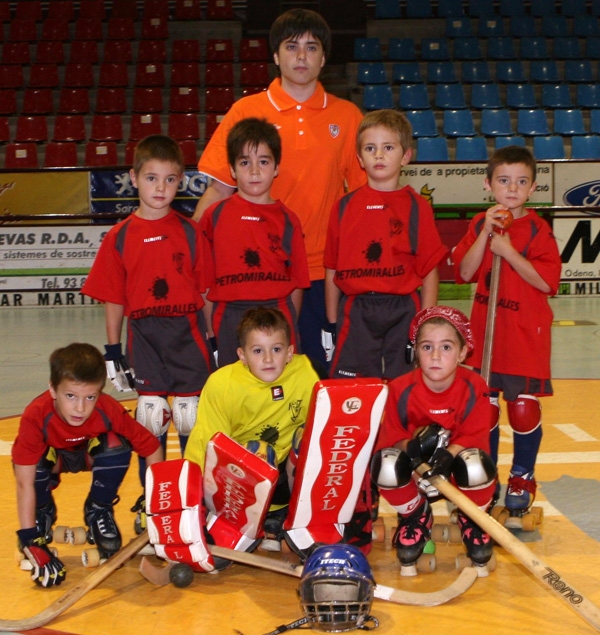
[392, 500, 435, 576]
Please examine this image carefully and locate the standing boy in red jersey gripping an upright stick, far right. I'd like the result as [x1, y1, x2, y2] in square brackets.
[453, 146, 561, 527]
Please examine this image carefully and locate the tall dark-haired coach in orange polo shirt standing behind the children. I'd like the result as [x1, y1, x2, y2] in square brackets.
[194, 9, 366, 365]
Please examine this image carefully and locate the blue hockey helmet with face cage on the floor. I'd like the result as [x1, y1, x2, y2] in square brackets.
[298, 544, 379, 633]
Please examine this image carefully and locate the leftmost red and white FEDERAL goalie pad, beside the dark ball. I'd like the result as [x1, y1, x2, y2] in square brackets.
[146, 459, 214, 571]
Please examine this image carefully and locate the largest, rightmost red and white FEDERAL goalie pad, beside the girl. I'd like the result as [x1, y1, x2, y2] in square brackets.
[283, 378, 388, 553]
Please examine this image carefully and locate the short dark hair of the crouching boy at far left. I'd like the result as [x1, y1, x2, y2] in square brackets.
[50, 342, 106, 389]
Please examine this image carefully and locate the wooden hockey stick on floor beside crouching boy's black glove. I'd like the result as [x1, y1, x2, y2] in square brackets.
[0, 531, 148, 632]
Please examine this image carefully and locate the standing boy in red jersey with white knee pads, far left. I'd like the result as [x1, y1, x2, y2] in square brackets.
[82, 135, 214, 513]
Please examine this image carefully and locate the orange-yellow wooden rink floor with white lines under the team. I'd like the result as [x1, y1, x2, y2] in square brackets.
[0, 309, 600, 635]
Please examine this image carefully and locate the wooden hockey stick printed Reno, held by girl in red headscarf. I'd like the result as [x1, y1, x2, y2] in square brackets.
[417, 463, 600, 631]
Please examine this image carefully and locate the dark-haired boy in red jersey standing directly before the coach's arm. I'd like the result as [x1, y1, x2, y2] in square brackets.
[200, 118, 310, 366]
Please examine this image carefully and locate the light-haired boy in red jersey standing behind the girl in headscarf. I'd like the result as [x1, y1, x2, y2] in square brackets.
[324, 110, 448, 378]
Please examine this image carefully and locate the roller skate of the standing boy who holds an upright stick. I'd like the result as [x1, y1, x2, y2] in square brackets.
[492, 467, 544, 531]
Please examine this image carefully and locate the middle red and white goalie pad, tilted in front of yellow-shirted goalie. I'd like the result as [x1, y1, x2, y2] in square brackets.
[204, 432, 279, 551]
